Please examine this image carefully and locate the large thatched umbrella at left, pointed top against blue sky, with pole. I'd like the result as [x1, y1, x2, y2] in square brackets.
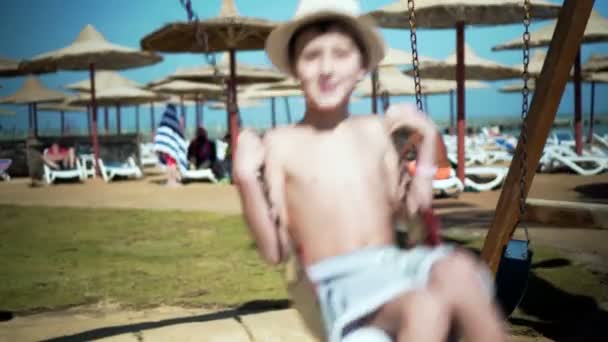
[26, 25, 162, 171]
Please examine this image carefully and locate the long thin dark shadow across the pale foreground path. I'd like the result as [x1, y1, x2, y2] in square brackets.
[44, 299, 290, 342]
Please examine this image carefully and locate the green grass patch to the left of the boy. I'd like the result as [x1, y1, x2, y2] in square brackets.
[0, 206, 286, 312]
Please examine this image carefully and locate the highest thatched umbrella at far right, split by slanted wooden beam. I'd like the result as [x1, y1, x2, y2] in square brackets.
[492, 11, 608, 155]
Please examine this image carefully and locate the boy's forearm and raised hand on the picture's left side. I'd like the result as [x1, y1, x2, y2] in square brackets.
[233, 130, 281, 264]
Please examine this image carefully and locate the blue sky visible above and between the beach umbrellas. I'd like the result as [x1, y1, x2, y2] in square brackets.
[0, 0, 608, 138]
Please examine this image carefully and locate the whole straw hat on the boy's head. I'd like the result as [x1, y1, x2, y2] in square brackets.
[266, 0, 385, 75]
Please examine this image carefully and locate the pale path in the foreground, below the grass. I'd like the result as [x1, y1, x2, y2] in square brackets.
[0, 307, 550, 342]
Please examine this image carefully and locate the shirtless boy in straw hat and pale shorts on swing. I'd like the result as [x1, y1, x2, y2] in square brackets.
[233, 0, 504, 342]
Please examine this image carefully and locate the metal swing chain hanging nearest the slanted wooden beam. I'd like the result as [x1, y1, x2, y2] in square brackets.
[519, 0, 531, 240]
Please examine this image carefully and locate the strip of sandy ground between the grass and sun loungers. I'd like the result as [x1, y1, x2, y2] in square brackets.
[0, 173, 608, 214]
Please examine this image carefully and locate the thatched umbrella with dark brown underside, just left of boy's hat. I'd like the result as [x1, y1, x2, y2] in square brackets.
[141, 0, 276, 155]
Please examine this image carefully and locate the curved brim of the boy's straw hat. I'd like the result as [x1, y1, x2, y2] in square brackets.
[266, 11, 386, 76]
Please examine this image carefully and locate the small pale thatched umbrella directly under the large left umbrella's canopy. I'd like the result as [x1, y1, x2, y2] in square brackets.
[65, 70, 143, 134]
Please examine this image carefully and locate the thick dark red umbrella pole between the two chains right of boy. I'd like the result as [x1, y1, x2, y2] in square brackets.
[456, 22, 465, 183]
